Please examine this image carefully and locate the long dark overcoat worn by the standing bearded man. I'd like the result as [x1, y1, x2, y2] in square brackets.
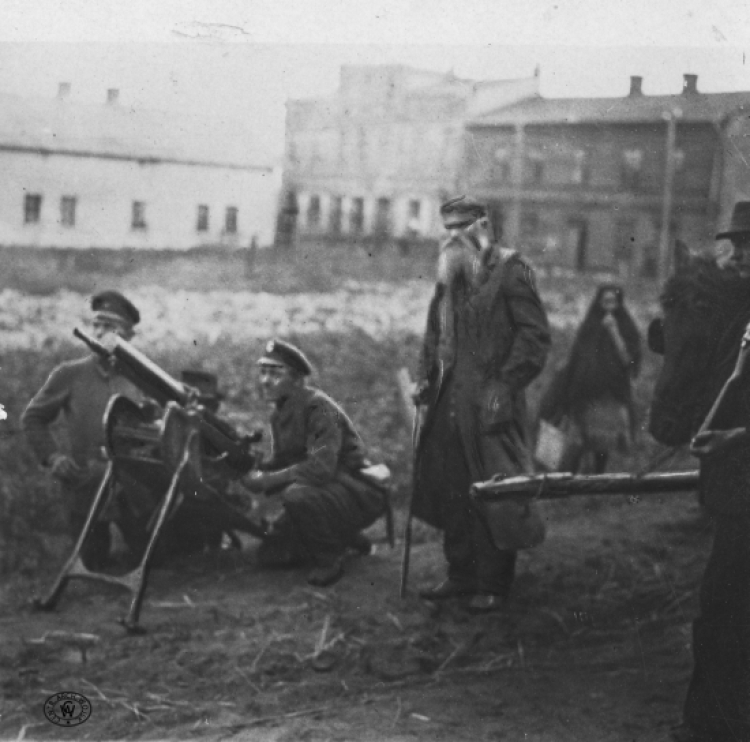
[412, 246, 550, 528]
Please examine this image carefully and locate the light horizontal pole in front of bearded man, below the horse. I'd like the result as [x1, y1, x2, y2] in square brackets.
[471, 470, 698, 500]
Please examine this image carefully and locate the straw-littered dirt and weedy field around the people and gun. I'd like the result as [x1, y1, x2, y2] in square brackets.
[0, 270, 711, 742]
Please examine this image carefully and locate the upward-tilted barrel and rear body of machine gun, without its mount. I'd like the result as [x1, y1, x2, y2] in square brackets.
[73, 328, 261, 471]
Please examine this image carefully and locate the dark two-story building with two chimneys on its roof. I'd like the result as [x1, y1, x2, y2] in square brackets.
[462, 75, 750, 275]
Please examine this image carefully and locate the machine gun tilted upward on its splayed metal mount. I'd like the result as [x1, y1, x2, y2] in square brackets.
[34, 329, 266, 633]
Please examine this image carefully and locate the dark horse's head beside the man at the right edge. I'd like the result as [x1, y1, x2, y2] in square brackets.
[648, 243, 750, 446]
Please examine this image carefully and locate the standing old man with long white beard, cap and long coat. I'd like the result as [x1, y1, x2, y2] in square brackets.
[412, 196, 550, 613]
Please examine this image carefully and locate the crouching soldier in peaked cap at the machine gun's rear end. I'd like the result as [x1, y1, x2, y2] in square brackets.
[246, 340, 388, 587]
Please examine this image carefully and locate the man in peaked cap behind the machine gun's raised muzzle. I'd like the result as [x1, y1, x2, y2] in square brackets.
[21, 291, 148, 569]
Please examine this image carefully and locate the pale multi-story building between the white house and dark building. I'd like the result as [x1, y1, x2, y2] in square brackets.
[284, 66, 538, 239]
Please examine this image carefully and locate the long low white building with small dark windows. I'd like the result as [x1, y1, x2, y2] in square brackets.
[0, 83, 280, 249]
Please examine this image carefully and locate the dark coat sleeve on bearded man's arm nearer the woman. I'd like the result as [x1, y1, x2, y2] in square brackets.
[501, 256, 551, 391]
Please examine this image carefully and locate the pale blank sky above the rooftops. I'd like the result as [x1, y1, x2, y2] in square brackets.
[0, 0, 750, 161]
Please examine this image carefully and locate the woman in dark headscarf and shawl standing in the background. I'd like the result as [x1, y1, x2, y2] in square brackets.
[539, 283, 642, 474]
